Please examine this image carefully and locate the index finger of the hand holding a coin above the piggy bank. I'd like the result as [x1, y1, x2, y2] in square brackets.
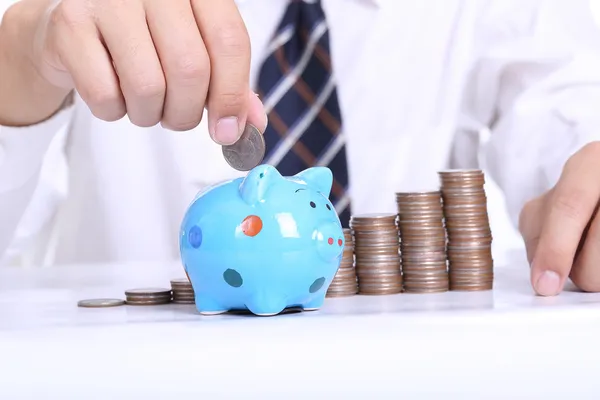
[192, 0, 250, 145]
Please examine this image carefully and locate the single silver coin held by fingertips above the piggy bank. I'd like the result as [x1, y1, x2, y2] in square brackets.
[222, 124, 265, 171]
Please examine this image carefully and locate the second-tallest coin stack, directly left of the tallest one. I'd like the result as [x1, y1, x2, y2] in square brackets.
[396, 191, 449, 293]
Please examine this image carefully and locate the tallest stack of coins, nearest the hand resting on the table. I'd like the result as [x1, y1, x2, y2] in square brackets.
[439, 170, 494, 291]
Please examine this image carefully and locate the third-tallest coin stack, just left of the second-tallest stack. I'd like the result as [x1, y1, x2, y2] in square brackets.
[350, 214, 402, 295]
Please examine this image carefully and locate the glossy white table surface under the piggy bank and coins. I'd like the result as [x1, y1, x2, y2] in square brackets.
[0, 248, 600, 400]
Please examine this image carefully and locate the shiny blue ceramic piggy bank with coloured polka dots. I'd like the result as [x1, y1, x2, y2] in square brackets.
[180, 165, 345, 316]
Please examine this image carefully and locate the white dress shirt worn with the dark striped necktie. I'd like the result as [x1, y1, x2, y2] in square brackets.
[0, 0, 600, 264]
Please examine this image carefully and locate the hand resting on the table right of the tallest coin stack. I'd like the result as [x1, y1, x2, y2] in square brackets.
[519, 142, 600, 296]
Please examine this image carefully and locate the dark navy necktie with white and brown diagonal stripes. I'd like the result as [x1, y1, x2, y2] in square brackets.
[258, 0, 351, 227]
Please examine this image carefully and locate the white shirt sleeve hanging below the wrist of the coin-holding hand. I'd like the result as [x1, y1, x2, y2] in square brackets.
[0, 104, 73, 258]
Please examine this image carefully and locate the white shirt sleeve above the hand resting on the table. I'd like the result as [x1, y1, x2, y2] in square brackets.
[453, 0, 600, 227]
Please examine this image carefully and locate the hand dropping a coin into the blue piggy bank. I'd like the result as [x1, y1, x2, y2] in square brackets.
[33, 0, 266, 144]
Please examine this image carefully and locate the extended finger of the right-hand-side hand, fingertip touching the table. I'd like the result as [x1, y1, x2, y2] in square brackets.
[531, 144, 600, 296]
